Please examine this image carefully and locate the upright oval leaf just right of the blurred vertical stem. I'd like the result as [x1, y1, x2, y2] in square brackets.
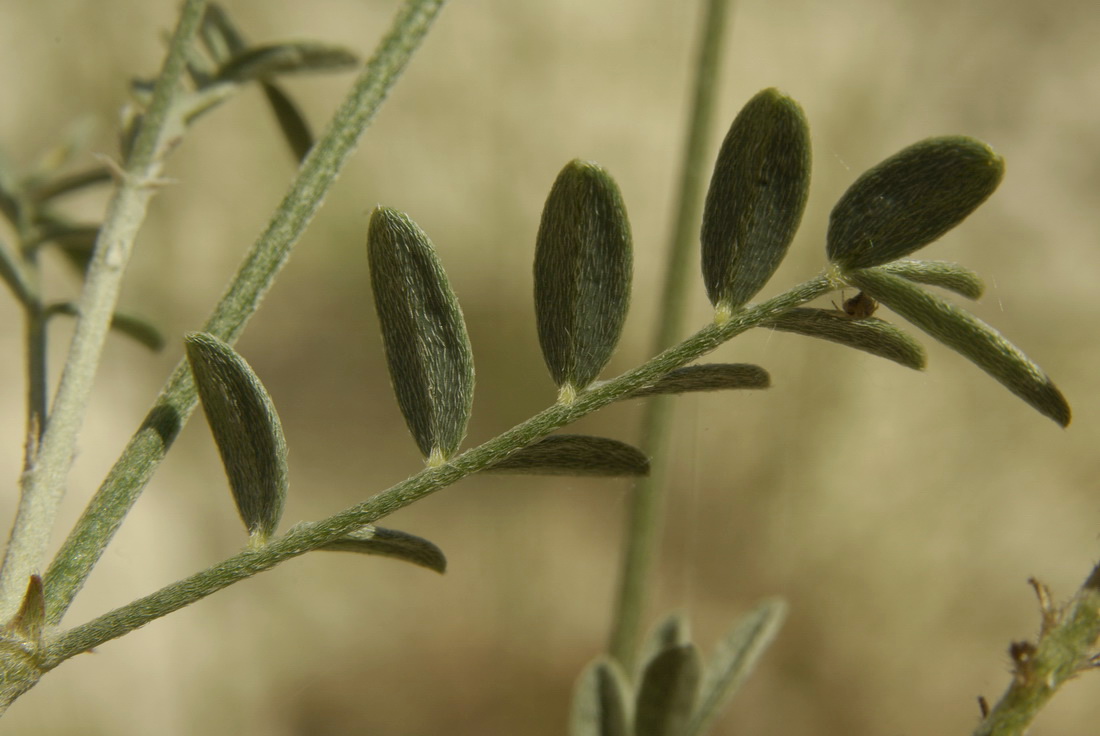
[702, 89, 810, 311]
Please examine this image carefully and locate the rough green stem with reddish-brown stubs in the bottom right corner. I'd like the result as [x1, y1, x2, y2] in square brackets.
[974, 558, 1100, 736]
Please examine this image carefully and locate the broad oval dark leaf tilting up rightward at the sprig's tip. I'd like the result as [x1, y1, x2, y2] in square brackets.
[826, 136, 1004, 270]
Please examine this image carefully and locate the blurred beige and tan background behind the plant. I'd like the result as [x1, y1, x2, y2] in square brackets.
[0, 0, 1100, 736]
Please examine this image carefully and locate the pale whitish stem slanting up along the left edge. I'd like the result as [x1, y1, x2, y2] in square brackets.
[0, 0, 206, 619]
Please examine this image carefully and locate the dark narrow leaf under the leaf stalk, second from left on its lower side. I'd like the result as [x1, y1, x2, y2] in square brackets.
[487, 435, 649, 476]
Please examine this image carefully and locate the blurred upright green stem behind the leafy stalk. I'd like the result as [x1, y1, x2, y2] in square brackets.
[609, 0, 730, 672]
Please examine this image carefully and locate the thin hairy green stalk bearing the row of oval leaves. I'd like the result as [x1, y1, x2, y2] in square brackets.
[42, 275, 833, 670]
